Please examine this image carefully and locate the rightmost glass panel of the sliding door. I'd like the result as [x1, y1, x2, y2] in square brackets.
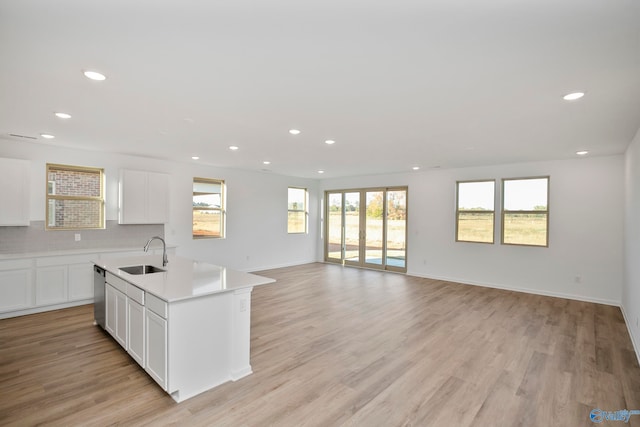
[386, 190, 407, 270]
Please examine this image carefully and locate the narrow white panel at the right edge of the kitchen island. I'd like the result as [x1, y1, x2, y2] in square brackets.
[229, 288, 253, 381]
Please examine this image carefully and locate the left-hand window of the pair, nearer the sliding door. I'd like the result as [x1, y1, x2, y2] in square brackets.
[456, 180, 496, 243]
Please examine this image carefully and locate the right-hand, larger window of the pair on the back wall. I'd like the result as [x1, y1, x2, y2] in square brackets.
[502, 177, 549, 246]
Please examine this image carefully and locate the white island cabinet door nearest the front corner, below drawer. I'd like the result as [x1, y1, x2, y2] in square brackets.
[145, 310, 167, 391]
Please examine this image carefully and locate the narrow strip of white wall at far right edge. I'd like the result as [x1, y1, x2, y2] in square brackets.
[622, 130, 640, 361]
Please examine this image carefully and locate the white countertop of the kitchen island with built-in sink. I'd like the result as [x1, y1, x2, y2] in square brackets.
[94, 255, 275, 302]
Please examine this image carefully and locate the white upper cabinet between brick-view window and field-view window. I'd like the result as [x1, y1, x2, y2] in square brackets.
[118, 169, 169, 224]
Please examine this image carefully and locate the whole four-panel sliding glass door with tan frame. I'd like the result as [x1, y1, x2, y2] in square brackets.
[325, 187, 407, 272]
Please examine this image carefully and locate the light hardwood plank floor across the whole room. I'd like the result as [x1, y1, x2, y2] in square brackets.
[0, 263, 640, 427]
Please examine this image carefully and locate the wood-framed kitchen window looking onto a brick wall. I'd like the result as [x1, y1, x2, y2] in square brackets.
[45, 164, 104, 230]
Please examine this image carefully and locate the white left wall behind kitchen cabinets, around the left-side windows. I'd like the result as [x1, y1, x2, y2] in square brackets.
[0, 139, 318, 271]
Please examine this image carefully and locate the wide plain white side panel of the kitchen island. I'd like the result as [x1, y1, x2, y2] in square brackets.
[168, 292, 233, 402]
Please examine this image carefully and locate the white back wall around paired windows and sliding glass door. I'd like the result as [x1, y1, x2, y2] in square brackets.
[318, 156, 624, 305]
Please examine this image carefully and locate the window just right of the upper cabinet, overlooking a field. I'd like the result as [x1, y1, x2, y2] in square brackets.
[193, 178, 225, 239]
